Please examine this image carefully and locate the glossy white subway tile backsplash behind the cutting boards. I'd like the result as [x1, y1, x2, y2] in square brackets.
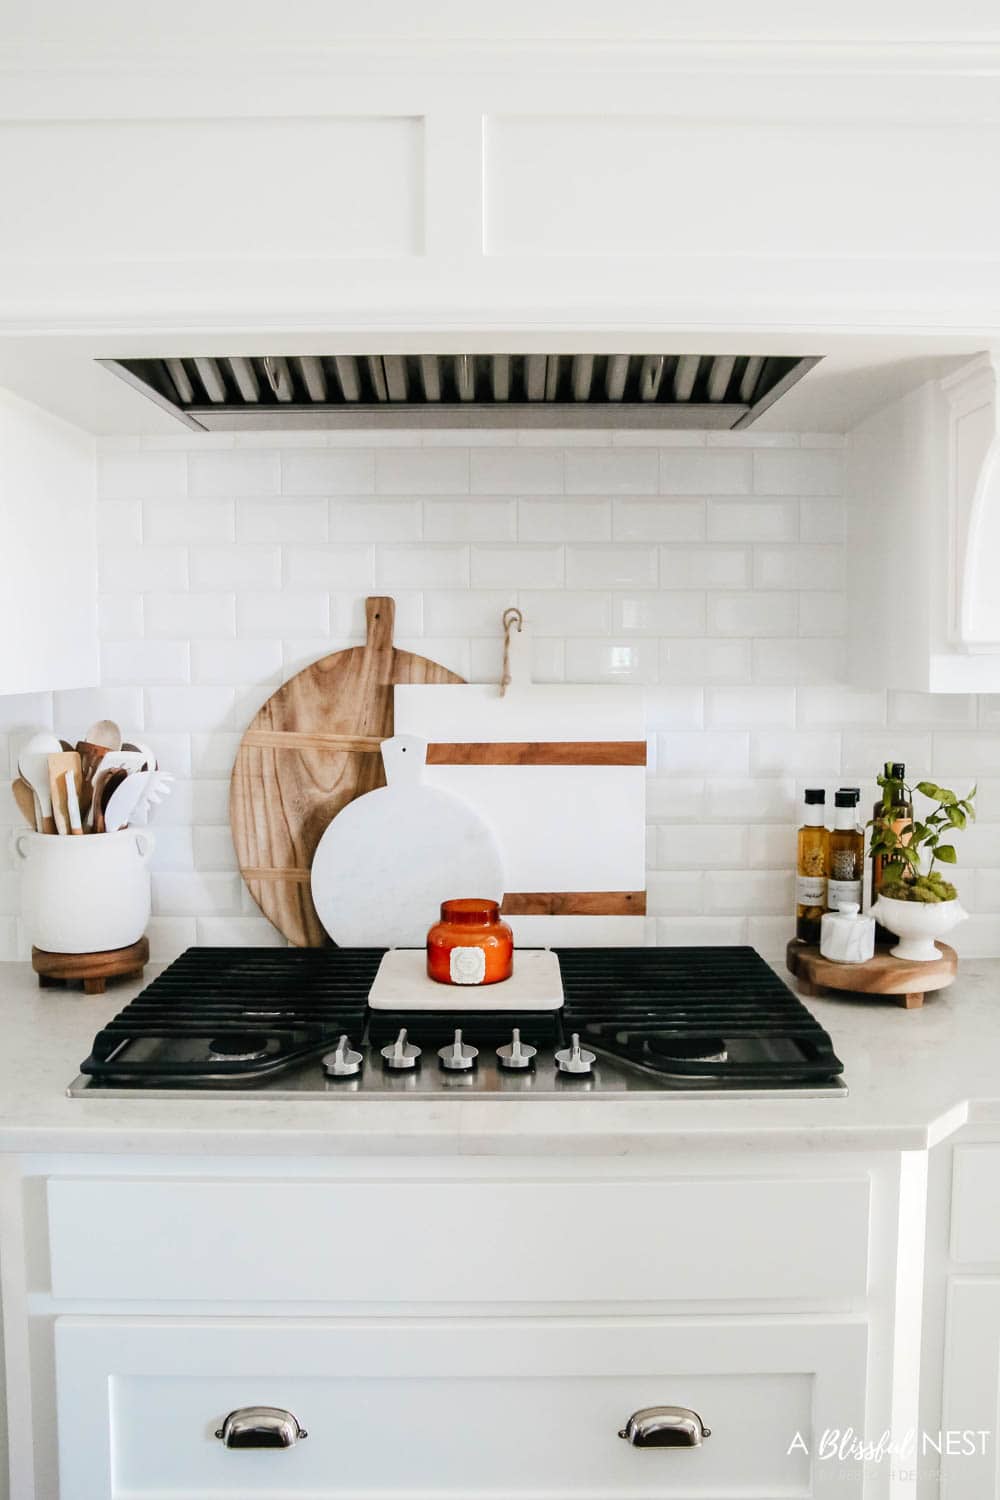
[7, 429, 1000, 959]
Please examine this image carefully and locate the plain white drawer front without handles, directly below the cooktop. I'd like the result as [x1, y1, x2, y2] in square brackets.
[48, 1178, 870, 1302]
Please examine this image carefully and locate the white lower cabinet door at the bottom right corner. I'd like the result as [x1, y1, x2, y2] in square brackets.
[941, 1277, 1000, 1500]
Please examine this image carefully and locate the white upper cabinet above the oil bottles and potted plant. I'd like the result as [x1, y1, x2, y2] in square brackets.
[847, 354, 1000, 693]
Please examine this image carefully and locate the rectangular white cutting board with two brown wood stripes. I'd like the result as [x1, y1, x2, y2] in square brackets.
[394, 630, 646, 947]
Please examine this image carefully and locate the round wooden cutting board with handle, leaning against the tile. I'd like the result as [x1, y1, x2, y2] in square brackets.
[229, 599, 465, 948]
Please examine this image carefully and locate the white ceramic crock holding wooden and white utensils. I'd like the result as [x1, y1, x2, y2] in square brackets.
[13, 828, 153, 953]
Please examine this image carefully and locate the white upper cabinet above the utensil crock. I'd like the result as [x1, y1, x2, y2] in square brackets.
[0, 390, 99, 693]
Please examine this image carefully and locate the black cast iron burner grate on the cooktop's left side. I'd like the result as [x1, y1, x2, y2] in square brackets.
[79, 948, 384, 1086]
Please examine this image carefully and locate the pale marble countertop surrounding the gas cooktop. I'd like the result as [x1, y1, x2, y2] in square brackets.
[0, 960, 1000, 1155]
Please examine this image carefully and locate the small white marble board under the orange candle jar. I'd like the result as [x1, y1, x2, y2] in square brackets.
[369, 948, 562, 1011]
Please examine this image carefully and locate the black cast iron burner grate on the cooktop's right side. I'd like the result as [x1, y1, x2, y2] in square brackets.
[558, 948, 843, 1088]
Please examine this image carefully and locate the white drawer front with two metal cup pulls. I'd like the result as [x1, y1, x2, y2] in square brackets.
[55, 1319, 867, 1500]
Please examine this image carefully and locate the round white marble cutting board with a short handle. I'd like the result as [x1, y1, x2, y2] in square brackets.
[312, 735, 504, 948]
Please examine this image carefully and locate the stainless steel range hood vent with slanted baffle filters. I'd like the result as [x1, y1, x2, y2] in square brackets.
[99, 354, 819, 432]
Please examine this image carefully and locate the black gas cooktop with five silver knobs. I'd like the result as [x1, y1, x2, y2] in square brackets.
[69, 948, 846, 1098]
